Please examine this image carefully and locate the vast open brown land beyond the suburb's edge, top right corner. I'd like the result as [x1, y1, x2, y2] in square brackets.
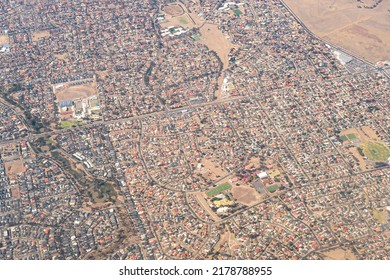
[285, 0, 390, 62]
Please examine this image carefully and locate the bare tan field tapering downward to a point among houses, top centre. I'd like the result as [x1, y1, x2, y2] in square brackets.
[199, 23, 234, 69]
